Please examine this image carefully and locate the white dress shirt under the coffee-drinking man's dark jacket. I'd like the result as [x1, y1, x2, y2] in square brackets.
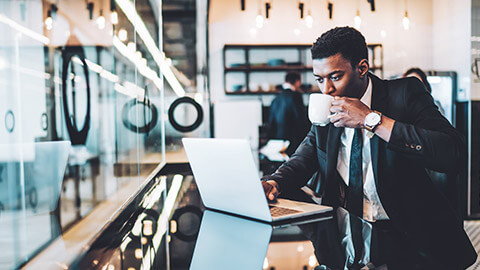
[337, 78, 389, 222]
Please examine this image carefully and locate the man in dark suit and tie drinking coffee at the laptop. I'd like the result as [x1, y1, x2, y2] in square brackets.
[262, 27, 477, 269]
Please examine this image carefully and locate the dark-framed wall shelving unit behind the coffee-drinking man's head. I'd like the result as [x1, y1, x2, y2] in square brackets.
[223, 44, 383, 95]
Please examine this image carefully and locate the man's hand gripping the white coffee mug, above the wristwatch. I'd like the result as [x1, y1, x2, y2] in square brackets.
[330, 97, 372, 128]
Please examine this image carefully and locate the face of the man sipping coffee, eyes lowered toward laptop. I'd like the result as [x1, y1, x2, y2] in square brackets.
[313, 53, 362, 98]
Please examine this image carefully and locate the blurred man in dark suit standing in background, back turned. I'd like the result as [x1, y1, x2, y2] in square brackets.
[268, 72, 310, 155]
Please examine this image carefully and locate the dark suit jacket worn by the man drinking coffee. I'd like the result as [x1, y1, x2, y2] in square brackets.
[264, 74, 477, 269]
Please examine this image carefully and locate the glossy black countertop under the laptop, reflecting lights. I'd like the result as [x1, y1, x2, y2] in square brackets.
[69, 168, 458, 270]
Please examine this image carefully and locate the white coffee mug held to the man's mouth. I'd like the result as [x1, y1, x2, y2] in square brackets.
[308, 93, 333, 126]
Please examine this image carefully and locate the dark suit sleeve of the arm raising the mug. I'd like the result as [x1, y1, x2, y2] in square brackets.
[388, 78, 466, 173]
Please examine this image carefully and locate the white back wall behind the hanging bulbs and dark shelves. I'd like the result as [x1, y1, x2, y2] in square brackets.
[209, 0, 471, 144]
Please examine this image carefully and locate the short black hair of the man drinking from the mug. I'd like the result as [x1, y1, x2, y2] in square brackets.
[311, 26, 368, 67]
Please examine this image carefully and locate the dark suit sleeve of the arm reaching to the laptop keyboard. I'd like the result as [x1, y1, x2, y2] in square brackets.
[262, 126, 318, 193]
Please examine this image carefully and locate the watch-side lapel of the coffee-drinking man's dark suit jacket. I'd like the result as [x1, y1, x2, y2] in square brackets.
[369, 74, 388, 189]
